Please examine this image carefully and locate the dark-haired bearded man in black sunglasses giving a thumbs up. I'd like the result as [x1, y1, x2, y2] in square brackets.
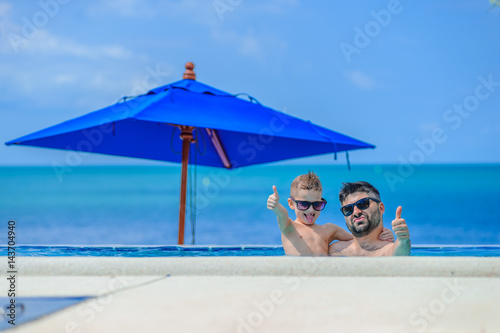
[328, 182, 411, 256]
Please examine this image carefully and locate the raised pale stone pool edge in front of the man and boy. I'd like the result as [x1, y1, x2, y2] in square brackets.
[6, 256, 500, 277]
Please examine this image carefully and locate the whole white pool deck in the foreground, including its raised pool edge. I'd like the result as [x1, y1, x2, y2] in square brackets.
[0, 257, 500, 333]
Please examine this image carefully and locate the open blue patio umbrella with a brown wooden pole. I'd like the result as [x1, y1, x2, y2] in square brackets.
[6, 62, 375, 244]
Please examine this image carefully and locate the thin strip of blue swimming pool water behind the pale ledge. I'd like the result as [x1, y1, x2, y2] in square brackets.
[0, 245, 500, 257]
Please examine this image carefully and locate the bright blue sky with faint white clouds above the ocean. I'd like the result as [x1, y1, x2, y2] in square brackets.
[0, 0, 500, 165]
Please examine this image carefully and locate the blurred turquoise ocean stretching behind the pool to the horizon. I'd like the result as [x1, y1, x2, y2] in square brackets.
[0, 165, 500, 245]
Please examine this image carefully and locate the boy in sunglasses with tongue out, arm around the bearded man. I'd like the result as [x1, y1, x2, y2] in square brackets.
[267, 171, 394, 256]
